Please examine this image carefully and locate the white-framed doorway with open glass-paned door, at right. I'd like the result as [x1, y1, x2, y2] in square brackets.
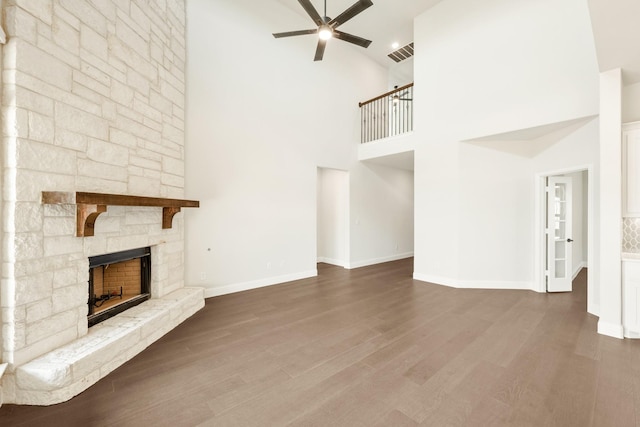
[535, 166, 597, 314]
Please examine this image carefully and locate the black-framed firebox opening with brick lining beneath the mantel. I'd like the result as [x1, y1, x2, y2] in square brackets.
[87, 247, 151, 327]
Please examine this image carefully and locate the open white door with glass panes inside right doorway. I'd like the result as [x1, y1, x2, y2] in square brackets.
[547, 176, 573, 292]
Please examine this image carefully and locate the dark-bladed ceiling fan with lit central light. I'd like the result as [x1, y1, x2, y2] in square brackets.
[273, 0, 373, 61]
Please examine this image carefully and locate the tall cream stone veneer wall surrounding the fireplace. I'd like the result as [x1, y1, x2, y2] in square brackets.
[0, 0, 186, 401]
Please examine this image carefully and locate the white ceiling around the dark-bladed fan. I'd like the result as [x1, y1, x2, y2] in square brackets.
[274, 0, 441, 68]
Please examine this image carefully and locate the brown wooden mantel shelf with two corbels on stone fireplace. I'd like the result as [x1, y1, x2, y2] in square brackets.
[42, 191, 200, 237]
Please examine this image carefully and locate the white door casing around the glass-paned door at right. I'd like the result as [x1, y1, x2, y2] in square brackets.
[534, 164, 600, 316]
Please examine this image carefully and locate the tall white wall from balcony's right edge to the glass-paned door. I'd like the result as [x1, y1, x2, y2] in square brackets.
[414, 0, 598, 288]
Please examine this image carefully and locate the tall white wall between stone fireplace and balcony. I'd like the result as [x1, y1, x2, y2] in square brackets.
[185, 0, 410, 296]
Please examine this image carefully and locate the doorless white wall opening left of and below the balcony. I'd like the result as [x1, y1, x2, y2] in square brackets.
[317, 168, 349, 267]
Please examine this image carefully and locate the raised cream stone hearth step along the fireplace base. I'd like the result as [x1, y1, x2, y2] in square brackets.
[12, 288, 204, 405]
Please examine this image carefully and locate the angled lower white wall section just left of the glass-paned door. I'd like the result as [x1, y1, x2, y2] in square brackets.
[457, 144, 533, 288]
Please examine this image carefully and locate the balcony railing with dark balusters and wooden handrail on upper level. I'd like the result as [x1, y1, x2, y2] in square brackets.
[359, 83, 413, 143]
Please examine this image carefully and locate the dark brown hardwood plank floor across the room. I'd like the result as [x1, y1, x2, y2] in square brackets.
[0, 259, 640, 427]
